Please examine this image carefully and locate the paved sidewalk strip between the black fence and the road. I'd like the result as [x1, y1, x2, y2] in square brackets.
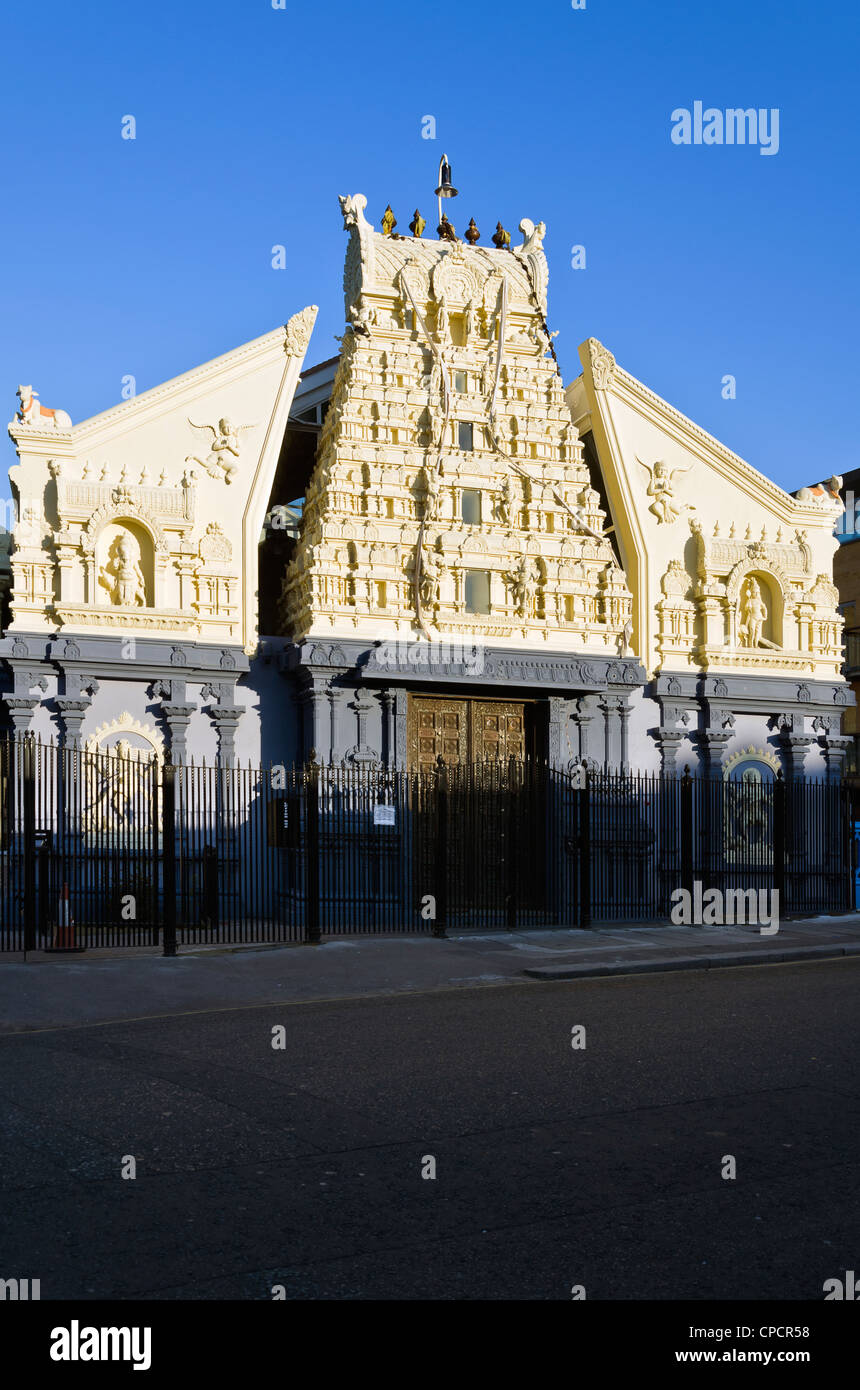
[0, 913, 860, 1033]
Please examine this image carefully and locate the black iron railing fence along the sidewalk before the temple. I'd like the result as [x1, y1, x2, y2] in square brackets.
[0, 738, 854, 954]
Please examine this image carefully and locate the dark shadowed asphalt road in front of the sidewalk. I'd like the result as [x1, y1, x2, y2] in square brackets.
[0, 959, 860, 1300]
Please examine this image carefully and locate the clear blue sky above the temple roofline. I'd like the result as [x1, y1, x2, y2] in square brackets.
[0, 0, 860, 491]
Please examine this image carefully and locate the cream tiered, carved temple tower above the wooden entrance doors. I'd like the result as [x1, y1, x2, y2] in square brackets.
[282, 196, 631, 656]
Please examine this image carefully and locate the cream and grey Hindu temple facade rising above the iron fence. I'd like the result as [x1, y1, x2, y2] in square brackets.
[0, 195, 853, 777]
